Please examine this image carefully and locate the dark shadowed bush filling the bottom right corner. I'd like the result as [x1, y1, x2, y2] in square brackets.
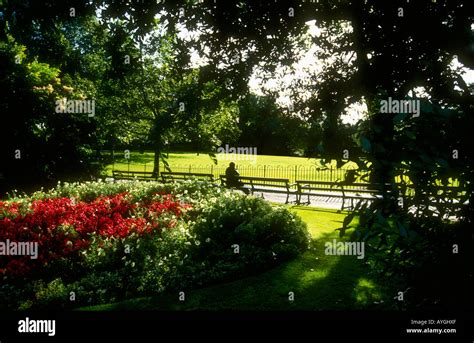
[348, 202, 474, 309]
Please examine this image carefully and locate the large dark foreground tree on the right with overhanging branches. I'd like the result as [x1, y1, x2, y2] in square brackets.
[90, 0, 474, 301]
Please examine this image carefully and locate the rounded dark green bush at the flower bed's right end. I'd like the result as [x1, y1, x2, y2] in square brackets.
[176, 195, 310, 284]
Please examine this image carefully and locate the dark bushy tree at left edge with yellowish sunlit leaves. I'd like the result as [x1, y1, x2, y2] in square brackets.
[0, 22, 101, 190]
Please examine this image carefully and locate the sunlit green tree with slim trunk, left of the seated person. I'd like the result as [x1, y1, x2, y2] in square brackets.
[98, 23, 243, 174]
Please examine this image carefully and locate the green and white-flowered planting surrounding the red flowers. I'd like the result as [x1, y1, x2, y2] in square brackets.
[0, 181, 310, 309]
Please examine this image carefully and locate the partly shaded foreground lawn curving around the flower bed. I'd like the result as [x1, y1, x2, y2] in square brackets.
[81, 206, 396, 310]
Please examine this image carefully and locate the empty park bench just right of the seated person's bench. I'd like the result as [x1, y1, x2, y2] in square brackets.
[296, 180, 396, 210]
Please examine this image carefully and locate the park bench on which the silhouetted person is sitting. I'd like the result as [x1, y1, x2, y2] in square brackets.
[219, 175, 296, 204]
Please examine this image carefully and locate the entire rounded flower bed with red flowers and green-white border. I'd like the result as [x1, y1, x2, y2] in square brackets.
[0, 181, 309, 309]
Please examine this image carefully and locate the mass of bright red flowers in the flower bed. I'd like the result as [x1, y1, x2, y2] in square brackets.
[0, 193, 187, 275]
